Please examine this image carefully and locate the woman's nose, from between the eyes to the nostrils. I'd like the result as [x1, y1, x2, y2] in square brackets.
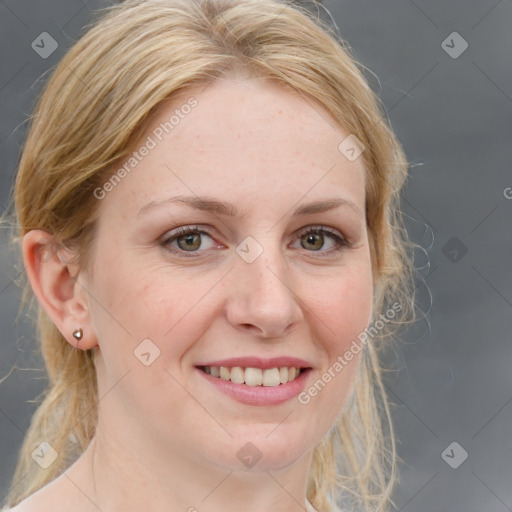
[227, 245, 303, 338]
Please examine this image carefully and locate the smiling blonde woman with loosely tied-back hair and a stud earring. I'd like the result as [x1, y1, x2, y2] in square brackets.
[3, 0, 413, 512]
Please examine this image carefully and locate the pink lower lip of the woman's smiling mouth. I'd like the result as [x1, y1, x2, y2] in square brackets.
[196, 368, 311, 405]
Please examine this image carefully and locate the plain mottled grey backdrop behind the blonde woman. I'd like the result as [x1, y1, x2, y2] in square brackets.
[0, 0, 512, 512]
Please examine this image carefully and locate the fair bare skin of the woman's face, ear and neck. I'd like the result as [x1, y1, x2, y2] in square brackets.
[16, 79, 373, 512]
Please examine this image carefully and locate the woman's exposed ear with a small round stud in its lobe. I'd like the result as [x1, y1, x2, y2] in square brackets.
[22, 229, 99, 350]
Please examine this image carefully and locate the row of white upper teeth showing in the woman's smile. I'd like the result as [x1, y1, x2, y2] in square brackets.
[203, 366, 300, 387]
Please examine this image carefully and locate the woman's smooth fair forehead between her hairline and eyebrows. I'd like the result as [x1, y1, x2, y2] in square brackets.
[98, 79, 364, 217]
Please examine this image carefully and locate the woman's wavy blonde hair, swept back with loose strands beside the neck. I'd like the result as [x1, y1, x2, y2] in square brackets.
[7, 0, 414, 512]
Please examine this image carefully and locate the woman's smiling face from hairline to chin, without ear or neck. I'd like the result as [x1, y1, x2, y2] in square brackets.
[81, 80, 373, 471]
